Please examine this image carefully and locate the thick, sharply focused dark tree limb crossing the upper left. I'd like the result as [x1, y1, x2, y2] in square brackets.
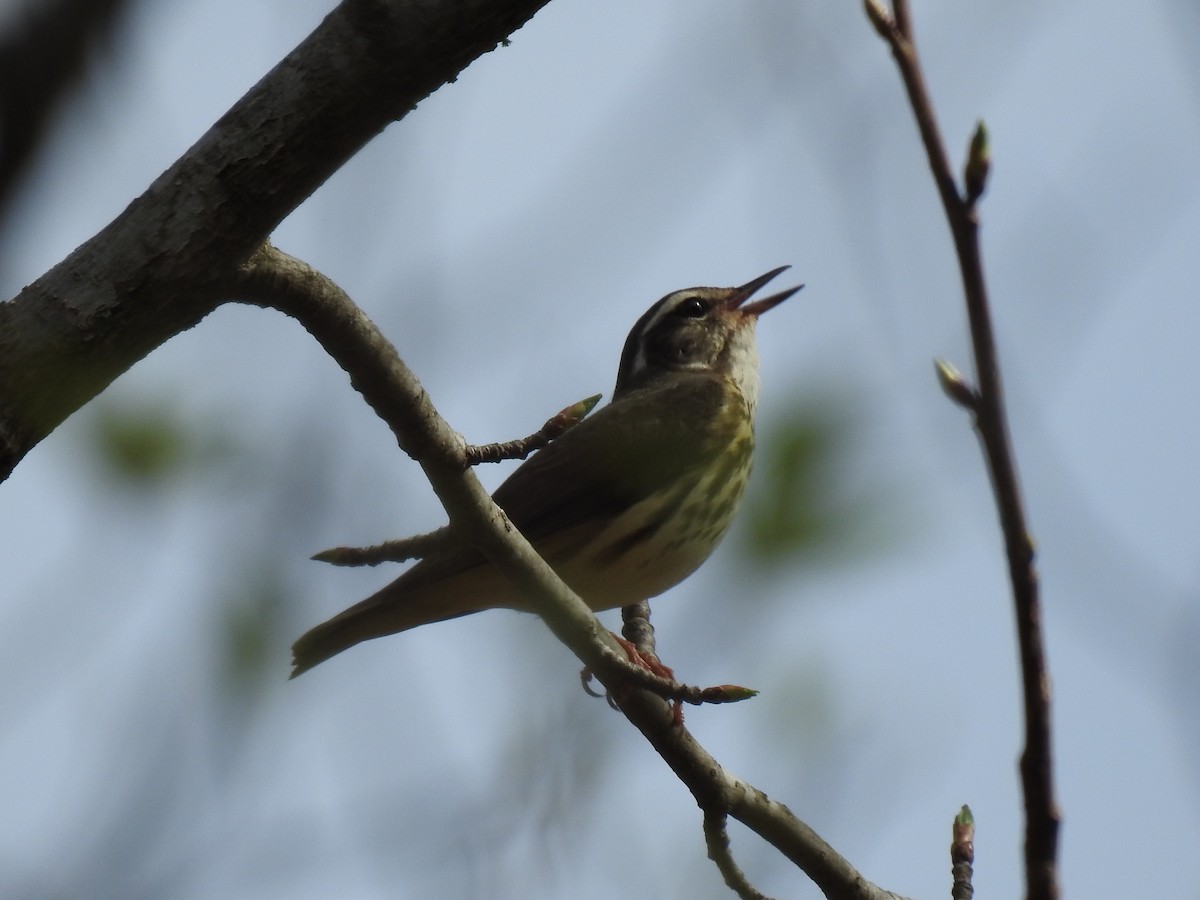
[0, 0, 546, 480]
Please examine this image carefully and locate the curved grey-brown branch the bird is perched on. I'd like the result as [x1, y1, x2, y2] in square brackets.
[229, 245, 896, 900]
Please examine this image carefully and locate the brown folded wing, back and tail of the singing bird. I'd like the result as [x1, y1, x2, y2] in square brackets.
[292, 374, 730, 678]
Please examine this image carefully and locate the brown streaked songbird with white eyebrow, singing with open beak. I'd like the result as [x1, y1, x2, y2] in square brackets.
[290, 265, 804, 678]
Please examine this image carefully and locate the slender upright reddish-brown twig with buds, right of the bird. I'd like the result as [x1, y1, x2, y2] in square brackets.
[865, 0, 1061, 900]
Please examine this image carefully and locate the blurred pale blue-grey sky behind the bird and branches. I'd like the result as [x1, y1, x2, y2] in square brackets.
[0, 0, 1200, 899]
